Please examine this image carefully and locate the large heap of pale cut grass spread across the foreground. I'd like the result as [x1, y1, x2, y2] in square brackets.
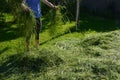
[0, 31, 120, 80]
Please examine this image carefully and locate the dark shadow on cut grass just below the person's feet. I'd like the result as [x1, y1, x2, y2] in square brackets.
[0, 51, 63, 79]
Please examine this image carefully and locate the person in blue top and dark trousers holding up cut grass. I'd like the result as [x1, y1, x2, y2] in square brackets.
[21, 0, 57, 51]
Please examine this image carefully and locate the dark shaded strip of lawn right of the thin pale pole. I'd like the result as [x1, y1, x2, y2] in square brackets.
[78, 15, 120, 32]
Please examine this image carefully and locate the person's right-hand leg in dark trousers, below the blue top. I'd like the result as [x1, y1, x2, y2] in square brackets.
[35, 18, 41, 48]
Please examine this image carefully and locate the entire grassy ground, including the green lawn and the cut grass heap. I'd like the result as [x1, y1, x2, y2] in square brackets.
[0, 15, 120, 80]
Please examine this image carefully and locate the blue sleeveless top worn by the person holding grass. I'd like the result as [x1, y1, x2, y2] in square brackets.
[26, 0, 41, 18]
